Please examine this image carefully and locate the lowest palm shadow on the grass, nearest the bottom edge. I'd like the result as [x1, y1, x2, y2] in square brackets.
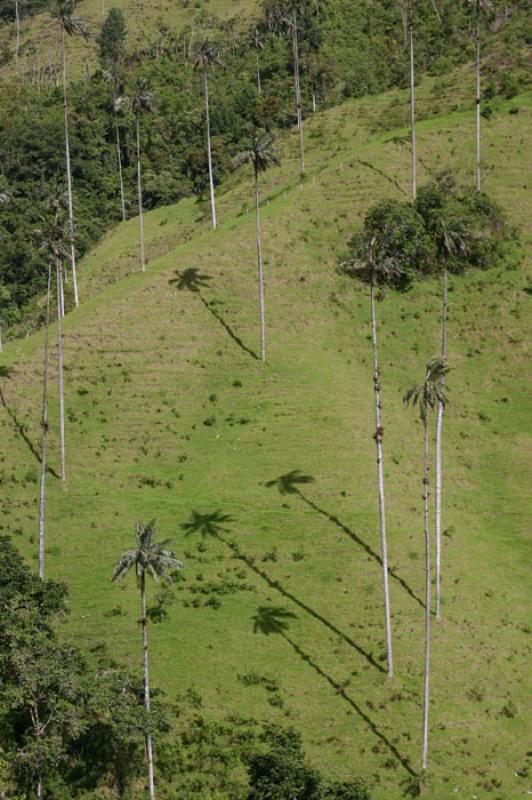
[253, 606, 417, 778]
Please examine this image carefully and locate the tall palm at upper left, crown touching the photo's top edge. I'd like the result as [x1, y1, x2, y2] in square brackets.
[49, 0, 88, 307]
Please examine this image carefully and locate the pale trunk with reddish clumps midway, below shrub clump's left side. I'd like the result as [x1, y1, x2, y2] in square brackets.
[370, 276, 393, 678]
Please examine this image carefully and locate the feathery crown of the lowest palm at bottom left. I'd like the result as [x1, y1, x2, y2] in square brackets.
[113, 520, 183, 581]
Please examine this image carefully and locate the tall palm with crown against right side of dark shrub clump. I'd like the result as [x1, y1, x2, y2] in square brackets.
[435, 219, 470, 619]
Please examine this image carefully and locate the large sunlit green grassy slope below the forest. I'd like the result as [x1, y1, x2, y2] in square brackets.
[0, 76, 532, 800]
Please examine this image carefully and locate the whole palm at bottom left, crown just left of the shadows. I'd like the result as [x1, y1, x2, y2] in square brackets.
[113, 520, 183, 800]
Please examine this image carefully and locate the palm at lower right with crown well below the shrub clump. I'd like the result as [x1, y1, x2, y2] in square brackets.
[404, 358, 449, 772]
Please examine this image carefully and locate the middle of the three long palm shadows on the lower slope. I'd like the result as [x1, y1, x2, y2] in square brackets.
[181, 511, 386, 673]
